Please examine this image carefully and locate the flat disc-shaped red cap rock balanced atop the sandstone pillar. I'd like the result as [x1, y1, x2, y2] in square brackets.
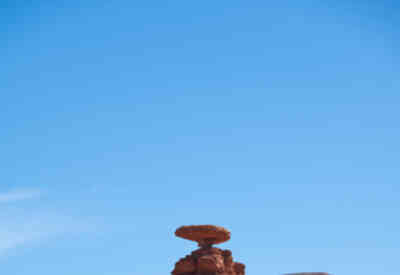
[175, 225, 231, 246]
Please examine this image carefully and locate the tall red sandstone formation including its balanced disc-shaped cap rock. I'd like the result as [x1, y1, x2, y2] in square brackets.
[172, 225, 245, 275]
